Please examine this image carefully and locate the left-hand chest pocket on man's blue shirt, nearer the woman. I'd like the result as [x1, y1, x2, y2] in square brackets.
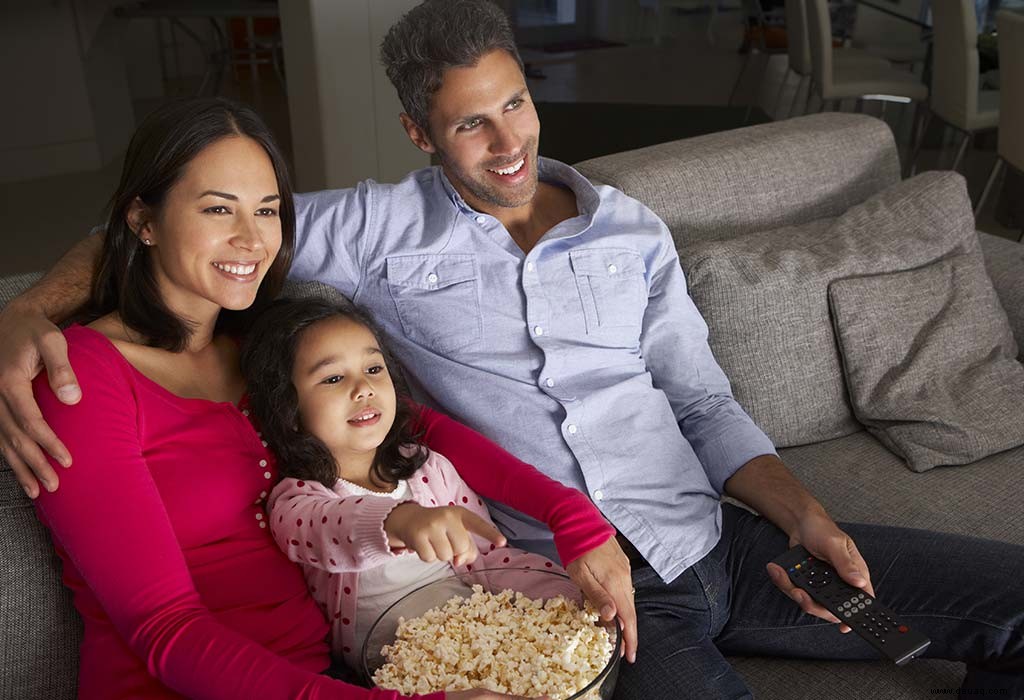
[387, 255, 483, 352]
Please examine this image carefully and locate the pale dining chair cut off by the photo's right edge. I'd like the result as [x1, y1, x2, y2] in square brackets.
[974, 10, 1024, 239]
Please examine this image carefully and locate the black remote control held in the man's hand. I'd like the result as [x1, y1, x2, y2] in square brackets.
[774, 544, 932, 665]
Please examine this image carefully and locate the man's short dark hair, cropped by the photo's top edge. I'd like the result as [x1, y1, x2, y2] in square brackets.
[381, 0, 522, 133]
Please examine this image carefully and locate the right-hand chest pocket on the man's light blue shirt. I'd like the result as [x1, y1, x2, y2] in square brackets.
[569, 248, 647, 334]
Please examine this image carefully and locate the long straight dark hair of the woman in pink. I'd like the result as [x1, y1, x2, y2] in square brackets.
[90, 97, 295, 352]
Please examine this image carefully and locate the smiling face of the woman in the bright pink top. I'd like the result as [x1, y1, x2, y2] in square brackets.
[135, 136, 282, 319]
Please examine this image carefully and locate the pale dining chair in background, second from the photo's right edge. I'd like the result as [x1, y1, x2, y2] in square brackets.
[910, 0, 999, 174]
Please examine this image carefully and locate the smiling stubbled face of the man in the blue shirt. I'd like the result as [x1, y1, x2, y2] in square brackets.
[428, 49, 541, 215]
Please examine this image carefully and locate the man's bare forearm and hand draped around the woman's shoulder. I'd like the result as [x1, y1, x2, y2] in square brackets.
[0, 234, 103, 498]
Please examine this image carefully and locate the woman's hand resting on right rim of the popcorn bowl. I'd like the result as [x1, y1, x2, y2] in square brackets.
[565, 537, 637, 663]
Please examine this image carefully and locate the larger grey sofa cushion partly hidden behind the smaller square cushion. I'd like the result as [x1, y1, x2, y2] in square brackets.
[681, 172, 977, 447]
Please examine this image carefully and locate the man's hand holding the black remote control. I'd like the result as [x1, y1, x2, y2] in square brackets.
[768, 511, 874, 635]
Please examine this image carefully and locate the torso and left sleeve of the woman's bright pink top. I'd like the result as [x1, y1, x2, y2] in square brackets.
[30, 326, 443, 700]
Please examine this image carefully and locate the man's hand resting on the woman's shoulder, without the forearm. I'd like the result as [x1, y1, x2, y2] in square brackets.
[0, 300, 82, 498]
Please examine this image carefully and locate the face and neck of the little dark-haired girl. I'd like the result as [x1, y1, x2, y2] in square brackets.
[292, 317, 396, 484]
